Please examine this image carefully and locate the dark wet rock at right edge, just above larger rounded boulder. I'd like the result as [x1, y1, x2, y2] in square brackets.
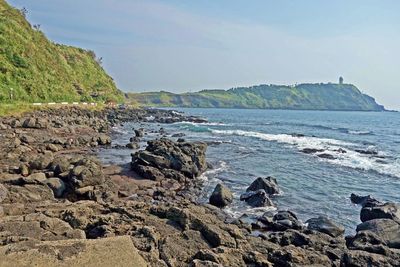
[360, 202, 400, 223]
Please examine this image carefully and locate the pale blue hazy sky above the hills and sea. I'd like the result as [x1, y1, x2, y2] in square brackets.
[8, 0, 400, 110]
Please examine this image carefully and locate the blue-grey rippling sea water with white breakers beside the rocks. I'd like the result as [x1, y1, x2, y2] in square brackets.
[100, 109, 400, 233]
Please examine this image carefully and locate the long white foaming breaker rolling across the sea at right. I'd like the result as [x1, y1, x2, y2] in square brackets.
[212, 130, 400, 178]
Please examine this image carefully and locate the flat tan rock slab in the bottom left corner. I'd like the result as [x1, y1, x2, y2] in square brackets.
[0, 236, 148, 267]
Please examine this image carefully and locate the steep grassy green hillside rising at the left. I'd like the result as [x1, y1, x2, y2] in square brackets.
[0, 0, 123, 103]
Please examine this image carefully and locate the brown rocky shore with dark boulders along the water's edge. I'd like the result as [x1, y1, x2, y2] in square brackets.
[0, 108, 400, 266]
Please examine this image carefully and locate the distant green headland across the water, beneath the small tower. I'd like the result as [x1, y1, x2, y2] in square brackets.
[128, 83, 384, 111]
